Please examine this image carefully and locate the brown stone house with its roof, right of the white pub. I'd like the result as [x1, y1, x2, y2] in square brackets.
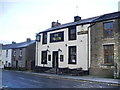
[90, 12, 120, 76]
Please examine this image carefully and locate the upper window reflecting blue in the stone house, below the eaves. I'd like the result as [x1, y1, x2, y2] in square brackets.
[103, 22, 113, 37]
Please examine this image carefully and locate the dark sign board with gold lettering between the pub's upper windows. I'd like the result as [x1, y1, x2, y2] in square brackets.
[50, 31, 64, 43]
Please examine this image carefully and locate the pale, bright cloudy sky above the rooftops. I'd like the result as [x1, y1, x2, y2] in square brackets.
[0, 0, 120, 44]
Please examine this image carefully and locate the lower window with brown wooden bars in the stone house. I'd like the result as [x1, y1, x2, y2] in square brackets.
[104, 45, 114, 64]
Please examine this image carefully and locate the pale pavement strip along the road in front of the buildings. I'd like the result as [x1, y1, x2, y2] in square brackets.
[12, 71, 120, 85]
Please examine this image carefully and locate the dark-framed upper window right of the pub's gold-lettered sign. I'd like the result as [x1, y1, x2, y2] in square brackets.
[68, 26, 76, 40]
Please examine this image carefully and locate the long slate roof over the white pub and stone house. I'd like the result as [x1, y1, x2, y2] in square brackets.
[39, 11, 120, 34]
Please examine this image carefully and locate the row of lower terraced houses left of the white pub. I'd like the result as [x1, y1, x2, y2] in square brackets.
[3, 38, 36, 70]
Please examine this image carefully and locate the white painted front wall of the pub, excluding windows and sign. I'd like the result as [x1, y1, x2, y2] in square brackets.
[36, 24, 89, 70]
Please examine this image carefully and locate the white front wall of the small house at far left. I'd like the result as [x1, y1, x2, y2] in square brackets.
[2, 49, 12, 67]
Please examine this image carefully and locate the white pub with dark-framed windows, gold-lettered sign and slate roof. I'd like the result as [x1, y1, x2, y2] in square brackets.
[35, 16, 98, 74]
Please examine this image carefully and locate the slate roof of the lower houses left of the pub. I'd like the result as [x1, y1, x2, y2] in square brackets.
[2, 40, 35, 49]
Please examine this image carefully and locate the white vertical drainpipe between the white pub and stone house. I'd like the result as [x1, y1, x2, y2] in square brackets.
[87, 23, 95, 72]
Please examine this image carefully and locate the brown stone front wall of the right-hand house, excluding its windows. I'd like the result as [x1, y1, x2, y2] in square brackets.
[90, 19, 120, 76]
